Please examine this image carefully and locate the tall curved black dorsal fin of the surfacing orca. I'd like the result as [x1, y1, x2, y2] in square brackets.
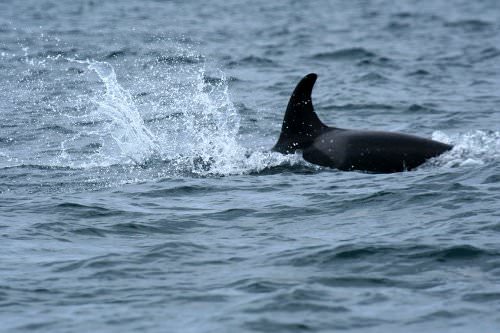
[273, 73, 328, 154]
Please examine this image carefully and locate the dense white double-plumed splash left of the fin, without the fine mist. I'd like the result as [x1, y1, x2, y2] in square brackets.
[53, 59, 296, 176]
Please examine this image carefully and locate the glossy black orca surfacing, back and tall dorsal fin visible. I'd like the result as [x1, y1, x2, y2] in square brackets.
[272, 73, 453, 173]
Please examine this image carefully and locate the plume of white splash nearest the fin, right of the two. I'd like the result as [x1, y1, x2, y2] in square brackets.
[149, 67, 304, 176]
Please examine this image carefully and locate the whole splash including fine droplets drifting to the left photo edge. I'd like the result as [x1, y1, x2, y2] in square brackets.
[7, 48, 318, 178]
